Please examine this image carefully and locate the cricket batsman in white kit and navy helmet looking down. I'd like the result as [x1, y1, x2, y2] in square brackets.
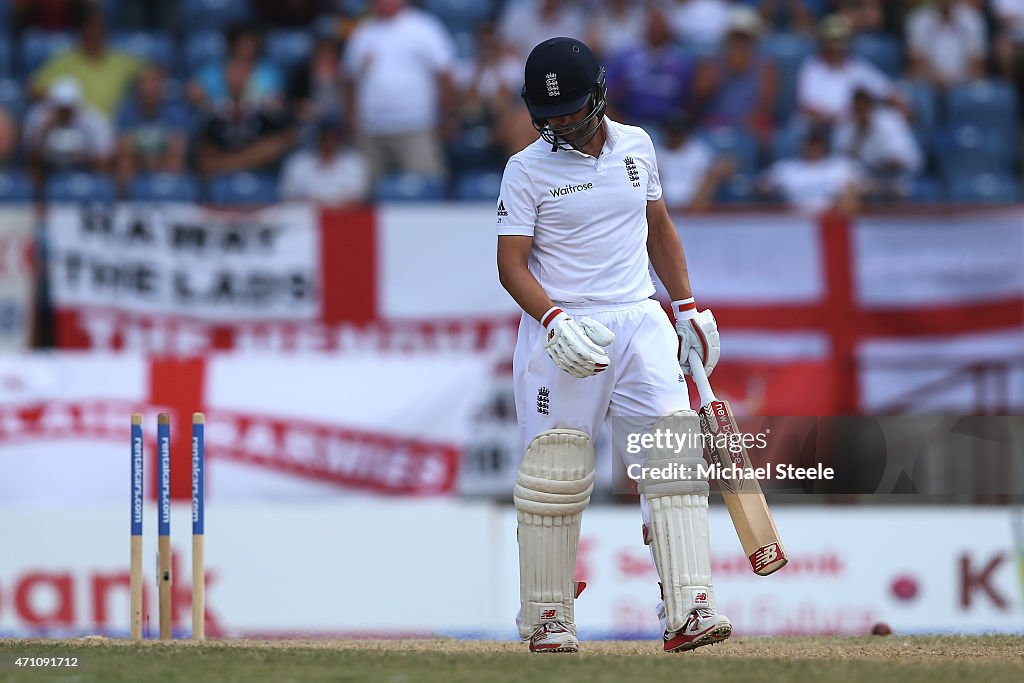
[498, 38, 732, 652]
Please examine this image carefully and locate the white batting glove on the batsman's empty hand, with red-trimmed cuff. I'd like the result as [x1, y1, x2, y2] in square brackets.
[541, 306, 615, 379]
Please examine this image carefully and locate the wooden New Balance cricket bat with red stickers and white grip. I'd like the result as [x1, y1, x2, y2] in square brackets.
[689, 349, 790, 577]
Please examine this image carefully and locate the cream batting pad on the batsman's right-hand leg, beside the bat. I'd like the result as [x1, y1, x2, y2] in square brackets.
[639, 411, 715, 631]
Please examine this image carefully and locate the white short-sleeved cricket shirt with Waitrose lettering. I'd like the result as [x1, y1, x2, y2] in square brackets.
[498, 118, 662, 307]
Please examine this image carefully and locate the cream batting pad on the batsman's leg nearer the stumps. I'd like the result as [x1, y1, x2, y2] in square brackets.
[513, 429, 594, 638]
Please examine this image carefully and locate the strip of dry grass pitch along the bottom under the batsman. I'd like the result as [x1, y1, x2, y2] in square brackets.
[0, 636, 1024, 683]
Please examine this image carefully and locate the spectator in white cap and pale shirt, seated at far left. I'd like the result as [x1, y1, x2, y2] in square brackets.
[25, 77, 114, 190]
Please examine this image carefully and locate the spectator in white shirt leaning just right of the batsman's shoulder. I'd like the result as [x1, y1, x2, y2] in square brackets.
[657, 118, 736, 211]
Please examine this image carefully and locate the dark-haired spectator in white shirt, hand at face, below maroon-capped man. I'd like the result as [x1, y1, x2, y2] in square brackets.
[834, 90, 924, 179]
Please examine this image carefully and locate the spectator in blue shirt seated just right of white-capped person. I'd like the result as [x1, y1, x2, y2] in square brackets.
[117, 66, 190, 191]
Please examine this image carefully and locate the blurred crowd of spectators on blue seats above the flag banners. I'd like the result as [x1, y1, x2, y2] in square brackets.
[0, 0, 1024, 211]
